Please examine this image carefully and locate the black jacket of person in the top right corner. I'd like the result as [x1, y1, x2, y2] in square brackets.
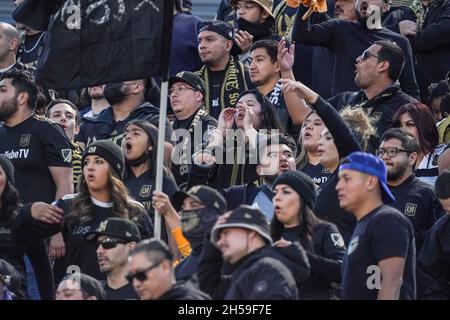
[385, 0, 450, 101]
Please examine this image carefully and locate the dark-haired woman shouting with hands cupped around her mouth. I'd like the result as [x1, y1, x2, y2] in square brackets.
[188, 89, 284, 189]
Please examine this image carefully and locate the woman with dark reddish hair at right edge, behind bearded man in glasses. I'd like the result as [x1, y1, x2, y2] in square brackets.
[392, 102, 445, 186]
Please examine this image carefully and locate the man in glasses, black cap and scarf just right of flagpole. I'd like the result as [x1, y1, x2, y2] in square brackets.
[169, 71, 217, 191]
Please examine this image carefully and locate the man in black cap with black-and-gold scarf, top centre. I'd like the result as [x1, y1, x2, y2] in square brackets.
[198, 21, 251, 119]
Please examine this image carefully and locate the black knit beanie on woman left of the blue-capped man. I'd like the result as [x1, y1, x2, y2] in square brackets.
[273, 171, 316, 209]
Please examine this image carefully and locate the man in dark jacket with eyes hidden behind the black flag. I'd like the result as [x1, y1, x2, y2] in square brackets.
[75, 79, 172, 159]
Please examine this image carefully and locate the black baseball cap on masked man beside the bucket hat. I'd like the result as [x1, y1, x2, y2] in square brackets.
[172, 185, 227, 214]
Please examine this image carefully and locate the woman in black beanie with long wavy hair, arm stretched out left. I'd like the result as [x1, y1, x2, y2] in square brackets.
[18, 140, 153, 282]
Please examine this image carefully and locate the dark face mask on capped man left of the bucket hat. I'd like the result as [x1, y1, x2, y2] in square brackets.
[181, 207, 219, 247]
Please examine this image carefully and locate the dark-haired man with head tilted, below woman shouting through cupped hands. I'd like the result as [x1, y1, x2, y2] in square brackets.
[190, 134, 297, 220]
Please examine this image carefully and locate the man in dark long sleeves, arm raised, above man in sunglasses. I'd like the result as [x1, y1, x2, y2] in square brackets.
[292, 0, 419, 98]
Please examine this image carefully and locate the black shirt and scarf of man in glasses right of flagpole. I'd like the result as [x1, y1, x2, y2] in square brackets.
[172, 110, 217, 191]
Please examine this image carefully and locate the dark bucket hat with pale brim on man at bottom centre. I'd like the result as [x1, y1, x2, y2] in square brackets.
[211, 205, 272, 245]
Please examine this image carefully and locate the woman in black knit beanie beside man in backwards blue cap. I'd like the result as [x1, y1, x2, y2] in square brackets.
[270, 171, 345, 300]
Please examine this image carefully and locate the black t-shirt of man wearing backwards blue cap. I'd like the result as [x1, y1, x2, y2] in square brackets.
[342, 205, 416, 300]
